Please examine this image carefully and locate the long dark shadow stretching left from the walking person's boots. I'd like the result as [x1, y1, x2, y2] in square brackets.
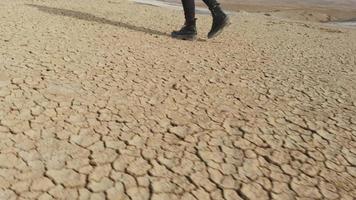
[26, 4, 170, 37]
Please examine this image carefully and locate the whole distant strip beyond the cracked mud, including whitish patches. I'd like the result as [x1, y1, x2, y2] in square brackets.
[138, 0, 356, 23]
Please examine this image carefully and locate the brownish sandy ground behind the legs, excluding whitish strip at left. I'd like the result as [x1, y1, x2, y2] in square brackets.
[193, 0, 356, 22]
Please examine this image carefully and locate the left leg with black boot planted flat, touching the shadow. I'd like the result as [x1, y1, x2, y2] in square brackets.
[172, 0, 197, 40]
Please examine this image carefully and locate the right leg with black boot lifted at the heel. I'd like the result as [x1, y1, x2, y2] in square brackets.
[203, 0, 230, 39]
